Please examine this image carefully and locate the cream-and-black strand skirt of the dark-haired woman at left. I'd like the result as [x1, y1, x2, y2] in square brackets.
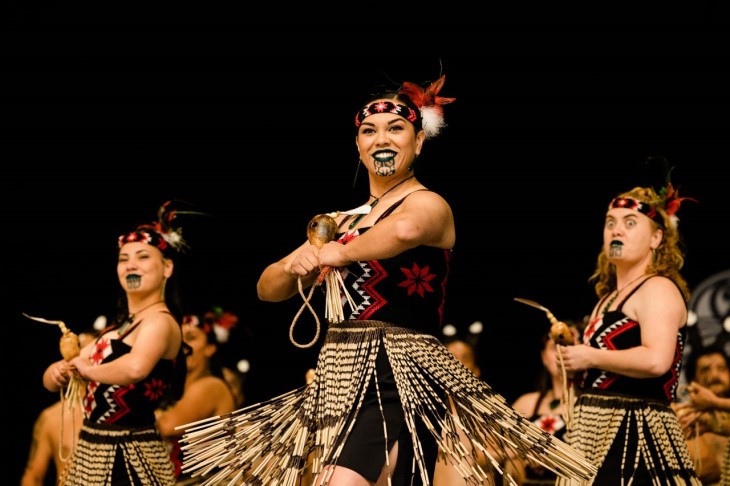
[58, 421, 175, 486]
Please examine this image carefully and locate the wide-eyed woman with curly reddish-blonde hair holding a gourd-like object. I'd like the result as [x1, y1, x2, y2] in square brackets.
[556, 177, 701, 486]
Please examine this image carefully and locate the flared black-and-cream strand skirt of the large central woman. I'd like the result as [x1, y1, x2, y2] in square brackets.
[180, 321, 596, 486]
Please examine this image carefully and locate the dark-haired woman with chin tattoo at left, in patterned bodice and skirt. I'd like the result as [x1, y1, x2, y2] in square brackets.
[43, 203, 186, 486]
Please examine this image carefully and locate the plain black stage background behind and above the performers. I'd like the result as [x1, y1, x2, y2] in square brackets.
[3, 2, 730, 484]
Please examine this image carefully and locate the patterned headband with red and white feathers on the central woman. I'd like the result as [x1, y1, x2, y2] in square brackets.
[355, 74, 456, 139]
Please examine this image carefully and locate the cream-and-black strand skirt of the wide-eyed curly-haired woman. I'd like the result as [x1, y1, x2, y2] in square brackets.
[555, 392, 702, 486]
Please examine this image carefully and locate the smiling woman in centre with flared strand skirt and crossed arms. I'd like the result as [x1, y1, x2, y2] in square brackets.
[182, 76, 592, 486]
